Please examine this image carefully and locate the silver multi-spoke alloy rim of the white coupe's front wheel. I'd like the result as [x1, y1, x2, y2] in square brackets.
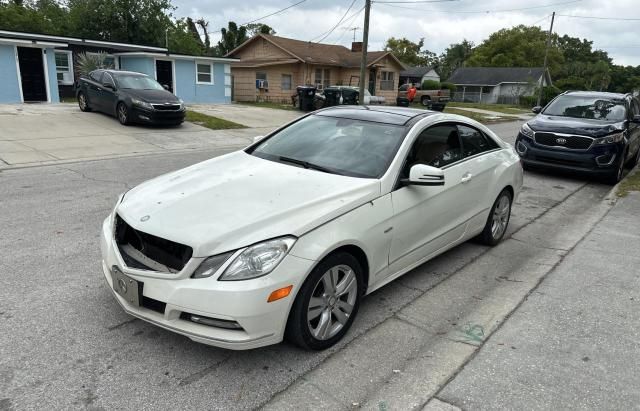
[307, 265, 358, 340]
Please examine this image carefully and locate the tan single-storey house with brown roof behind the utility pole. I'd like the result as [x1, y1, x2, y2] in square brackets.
[226, 34, 404, 103]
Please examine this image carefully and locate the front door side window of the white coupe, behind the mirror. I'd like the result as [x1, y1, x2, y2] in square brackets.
[403, 124, 463, 176]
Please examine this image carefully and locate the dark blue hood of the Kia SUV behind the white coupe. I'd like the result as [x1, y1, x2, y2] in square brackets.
[527, 114, 625, 138]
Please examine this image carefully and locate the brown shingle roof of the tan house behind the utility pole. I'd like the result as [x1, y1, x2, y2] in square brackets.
[227, 34, 400, 67]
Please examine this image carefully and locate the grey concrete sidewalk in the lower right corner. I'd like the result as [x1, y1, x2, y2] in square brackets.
[436, 188, 640, 410]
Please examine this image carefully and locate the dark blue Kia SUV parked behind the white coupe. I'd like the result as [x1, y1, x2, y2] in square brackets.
[516, 91, 640, 184]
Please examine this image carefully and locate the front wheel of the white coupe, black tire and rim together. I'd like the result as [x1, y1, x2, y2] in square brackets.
[285, 252, 364, 350]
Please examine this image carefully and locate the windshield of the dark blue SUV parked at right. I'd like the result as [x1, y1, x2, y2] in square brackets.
[543, 96, 626, 122]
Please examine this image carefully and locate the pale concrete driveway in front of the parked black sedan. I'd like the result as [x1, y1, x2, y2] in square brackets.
[0, 104, 262, 168]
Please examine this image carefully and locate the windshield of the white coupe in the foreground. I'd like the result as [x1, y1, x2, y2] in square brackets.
[252, 115, 404, 178]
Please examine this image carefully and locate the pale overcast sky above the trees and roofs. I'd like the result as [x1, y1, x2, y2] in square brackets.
[173, 0, 640, 66]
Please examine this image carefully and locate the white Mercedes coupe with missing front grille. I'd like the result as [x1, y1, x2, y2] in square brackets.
[101, 106, 522, 350]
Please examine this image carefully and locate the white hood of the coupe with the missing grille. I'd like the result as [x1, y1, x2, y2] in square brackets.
[117, 151, 380, 257]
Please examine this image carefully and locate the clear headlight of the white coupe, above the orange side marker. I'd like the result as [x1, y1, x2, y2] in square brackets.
[219, 237, 296, 281]
